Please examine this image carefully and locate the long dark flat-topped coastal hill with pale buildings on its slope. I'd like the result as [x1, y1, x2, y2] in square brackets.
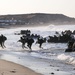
[0, 13, 75, 26]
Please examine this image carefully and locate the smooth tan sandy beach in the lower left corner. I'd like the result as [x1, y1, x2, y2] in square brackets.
[0, 59, 41, 75]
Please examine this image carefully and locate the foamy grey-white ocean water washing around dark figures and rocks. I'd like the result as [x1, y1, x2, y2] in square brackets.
[0, 25, 75, 75]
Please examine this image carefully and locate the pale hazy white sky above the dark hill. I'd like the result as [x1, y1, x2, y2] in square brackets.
[0, 0, 75, 17]
